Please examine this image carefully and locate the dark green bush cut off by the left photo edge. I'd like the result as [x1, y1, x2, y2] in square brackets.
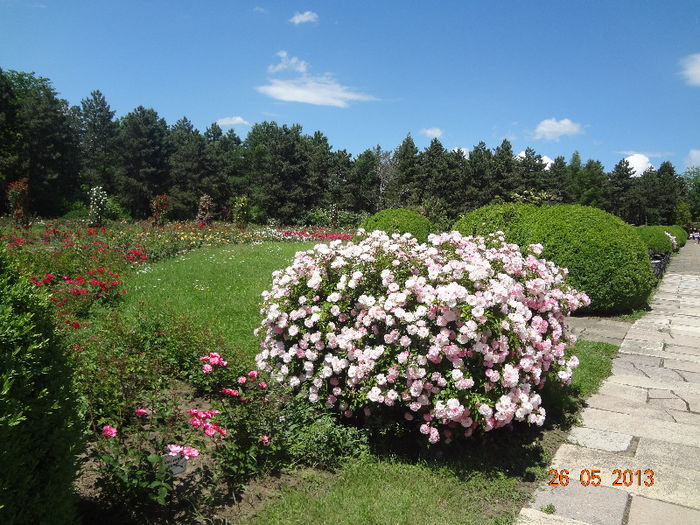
[0, 248, 80, 523]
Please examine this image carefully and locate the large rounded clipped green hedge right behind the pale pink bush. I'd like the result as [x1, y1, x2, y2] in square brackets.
[454, 204, 656, 314]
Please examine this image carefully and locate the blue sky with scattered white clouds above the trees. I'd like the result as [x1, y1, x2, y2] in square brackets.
[0, 0, 700, 171]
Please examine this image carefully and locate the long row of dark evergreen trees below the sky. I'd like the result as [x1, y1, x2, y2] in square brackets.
[0, 69, 700, 227]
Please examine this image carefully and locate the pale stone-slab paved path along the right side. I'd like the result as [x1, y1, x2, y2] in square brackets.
[517, 243, 700, 525]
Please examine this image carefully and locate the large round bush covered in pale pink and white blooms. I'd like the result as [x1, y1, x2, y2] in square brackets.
[256, 231, 589, 443]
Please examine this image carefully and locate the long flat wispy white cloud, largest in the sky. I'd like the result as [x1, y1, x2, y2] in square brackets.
[255, 74, 376, 108]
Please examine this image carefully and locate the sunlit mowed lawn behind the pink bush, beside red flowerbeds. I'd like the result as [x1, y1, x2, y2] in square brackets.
[122, 242, 315, 358]
